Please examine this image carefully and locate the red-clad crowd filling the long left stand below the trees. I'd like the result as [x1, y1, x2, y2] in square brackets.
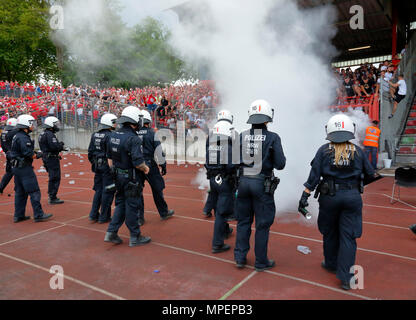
[0, 81, 219, 135]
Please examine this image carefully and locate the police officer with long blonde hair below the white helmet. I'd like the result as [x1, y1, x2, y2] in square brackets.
[299, 114, 377, 290]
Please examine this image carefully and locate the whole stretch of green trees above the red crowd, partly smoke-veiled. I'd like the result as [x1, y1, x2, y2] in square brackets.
[0, 0, 193, 88]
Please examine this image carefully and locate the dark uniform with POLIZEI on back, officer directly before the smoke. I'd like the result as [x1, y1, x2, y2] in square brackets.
[234, 124, 286, 271]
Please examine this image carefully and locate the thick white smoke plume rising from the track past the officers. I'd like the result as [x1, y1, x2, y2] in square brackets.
[172, 0, 370, 221]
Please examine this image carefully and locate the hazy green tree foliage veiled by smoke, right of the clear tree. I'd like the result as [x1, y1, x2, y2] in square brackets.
[59, 13, 191, 88]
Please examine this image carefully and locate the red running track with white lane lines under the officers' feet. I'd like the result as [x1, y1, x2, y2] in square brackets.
[0, 154, 416, 300]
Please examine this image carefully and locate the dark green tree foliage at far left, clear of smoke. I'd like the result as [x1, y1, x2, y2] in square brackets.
[0, 0, 58, 82]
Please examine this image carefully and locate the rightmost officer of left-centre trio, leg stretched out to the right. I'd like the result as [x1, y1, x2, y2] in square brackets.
[138, 110, 174, 225]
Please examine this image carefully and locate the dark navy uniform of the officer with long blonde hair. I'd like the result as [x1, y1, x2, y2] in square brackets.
[304, 143, 375, 282]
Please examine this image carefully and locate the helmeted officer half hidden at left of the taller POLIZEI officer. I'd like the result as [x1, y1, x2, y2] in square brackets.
[205, 121, 239, 253]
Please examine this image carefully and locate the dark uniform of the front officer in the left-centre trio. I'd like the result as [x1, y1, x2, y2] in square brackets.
[107, 125, 144, 239]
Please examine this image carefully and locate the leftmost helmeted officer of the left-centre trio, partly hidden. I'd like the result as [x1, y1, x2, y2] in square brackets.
[88, 113, 117, 223]
